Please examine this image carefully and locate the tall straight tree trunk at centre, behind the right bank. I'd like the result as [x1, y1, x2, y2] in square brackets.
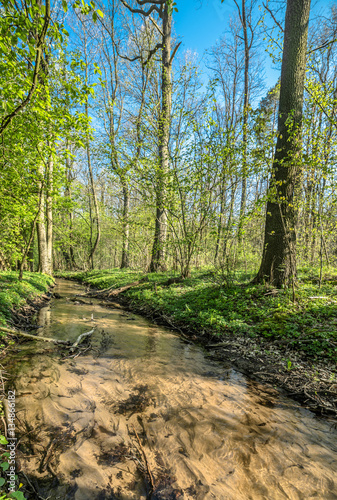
[150, 3, 172, 272]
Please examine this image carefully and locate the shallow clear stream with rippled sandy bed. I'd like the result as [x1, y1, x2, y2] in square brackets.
[7, 280, 337, 500]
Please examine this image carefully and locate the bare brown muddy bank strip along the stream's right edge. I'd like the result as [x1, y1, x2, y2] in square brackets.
[106, 294, 337, 420]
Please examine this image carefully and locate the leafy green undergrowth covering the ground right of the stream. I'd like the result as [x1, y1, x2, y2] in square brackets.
[58, 269, 337, 362]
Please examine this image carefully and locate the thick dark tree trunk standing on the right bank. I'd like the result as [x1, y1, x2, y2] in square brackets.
[255, 0, 310, 287]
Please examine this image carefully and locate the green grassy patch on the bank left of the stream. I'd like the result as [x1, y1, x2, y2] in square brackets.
[0, 271, 53, 326]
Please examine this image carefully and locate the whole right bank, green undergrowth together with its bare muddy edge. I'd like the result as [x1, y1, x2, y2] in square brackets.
[59, 269, 337, 417]
